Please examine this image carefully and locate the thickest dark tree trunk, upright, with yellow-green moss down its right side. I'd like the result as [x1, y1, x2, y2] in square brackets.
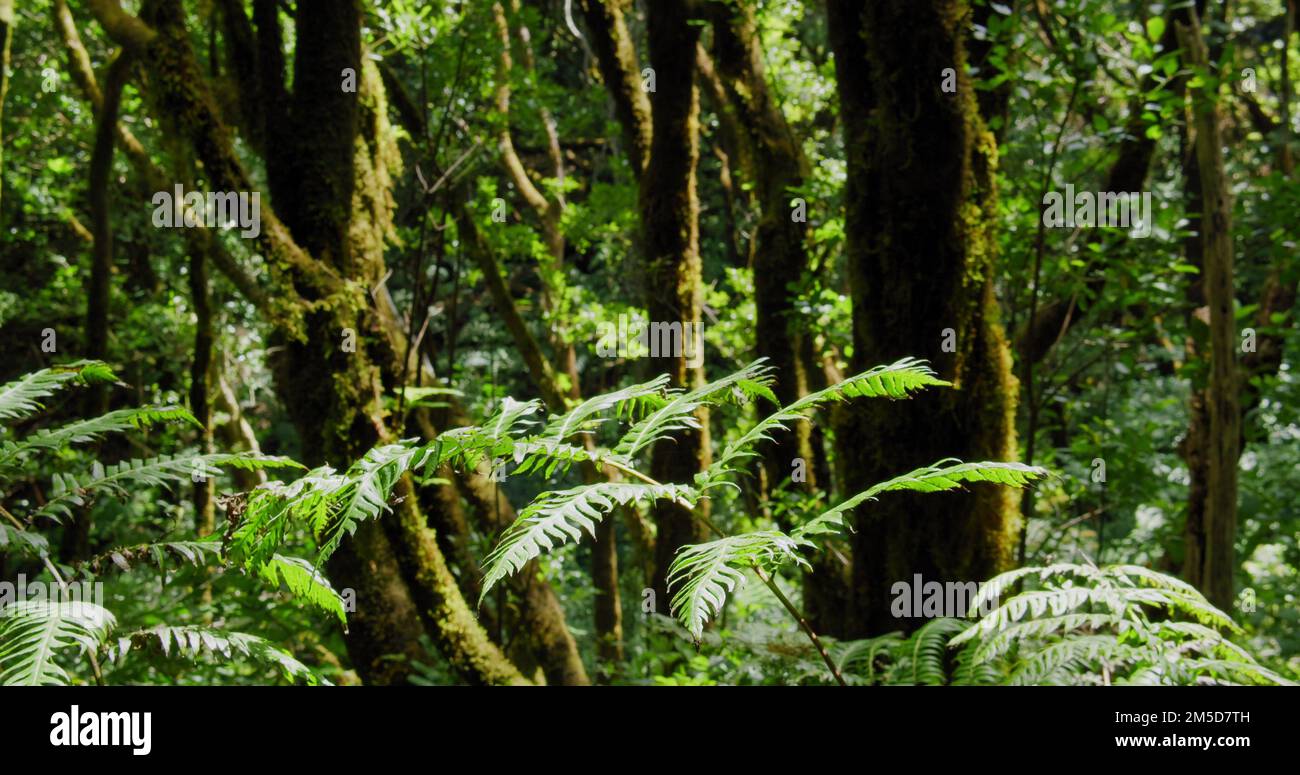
[829, 0, 1018, 636]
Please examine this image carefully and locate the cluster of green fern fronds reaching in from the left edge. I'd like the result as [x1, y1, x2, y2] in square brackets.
[0, 361, 322, 685]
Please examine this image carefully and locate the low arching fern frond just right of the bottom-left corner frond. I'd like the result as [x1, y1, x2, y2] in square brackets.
[108, 624, 329, 685]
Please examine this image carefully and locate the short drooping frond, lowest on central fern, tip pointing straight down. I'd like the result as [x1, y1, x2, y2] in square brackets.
[668, 531, 811, 642]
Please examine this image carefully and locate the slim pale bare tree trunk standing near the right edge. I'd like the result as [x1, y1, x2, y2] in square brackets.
[1178, 9, 1242, 609]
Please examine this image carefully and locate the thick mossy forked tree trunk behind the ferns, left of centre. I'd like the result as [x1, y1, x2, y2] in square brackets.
[87, 0, 524, 683]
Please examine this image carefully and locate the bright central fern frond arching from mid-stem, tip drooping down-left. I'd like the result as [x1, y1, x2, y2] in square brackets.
[478, 481, 698, 603]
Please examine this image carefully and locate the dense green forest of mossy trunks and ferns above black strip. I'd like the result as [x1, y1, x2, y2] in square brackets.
[0, 0, 1300, 685]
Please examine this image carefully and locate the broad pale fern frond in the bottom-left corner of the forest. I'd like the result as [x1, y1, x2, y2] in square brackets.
[0, 601, 113, 687]
